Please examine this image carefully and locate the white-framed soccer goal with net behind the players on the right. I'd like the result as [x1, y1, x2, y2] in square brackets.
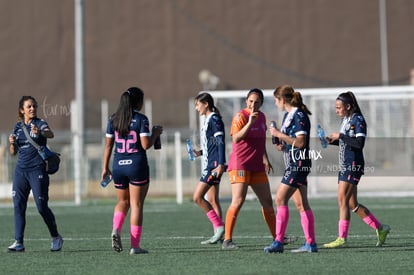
[210, 86, 414, 196]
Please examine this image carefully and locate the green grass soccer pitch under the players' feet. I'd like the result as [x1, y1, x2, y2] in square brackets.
[0, 198, 414, 274]
